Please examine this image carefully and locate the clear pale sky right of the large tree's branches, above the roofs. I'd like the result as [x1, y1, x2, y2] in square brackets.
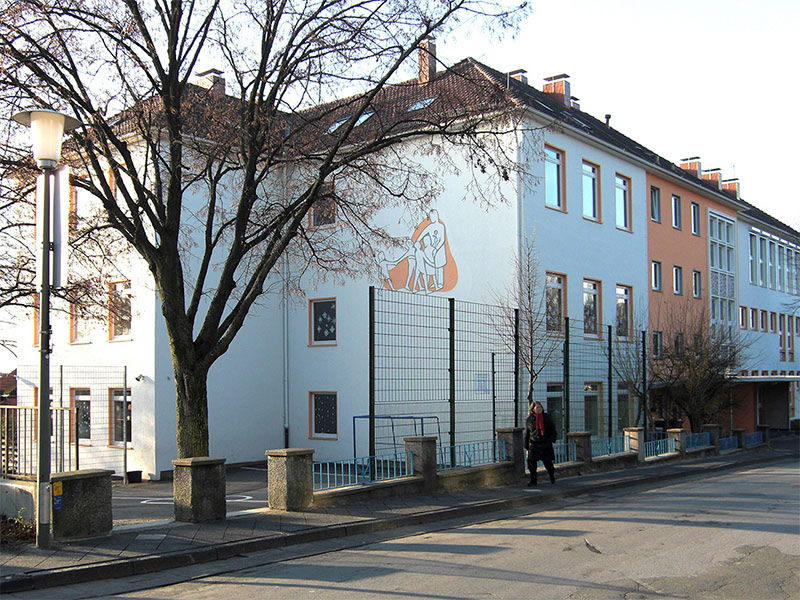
[437, 0, 800, 230]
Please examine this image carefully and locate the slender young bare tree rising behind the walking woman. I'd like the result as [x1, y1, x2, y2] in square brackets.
[493, 237, 564, 404]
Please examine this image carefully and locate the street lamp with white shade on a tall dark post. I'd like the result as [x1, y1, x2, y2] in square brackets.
[12, 110, 79, 548]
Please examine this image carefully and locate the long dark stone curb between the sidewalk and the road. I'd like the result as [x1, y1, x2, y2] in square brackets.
[0, 455, 792, 594]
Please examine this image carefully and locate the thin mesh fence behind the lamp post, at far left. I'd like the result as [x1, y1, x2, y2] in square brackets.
[0, 365, 130, 478]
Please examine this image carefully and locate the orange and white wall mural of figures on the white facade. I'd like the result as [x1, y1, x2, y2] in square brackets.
[378, 210, 458, 294]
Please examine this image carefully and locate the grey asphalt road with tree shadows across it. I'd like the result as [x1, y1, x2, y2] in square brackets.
[95, 462, 800, 600]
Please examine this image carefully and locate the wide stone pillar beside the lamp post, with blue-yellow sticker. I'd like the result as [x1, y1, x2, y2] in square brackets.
[50, 469, 114, 540]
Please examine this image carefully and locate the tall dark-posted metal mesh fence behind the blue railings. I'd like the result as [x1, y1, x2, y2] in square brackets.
[371, 290, 645, 452]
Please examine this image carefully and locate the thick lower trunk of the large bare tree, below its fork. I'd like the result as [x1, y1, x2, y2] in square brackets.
[173, 358, 209, 458]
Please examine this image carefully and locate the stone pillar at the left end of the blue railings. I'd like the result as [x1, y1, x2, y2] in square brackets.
[266, 448, 314, 511]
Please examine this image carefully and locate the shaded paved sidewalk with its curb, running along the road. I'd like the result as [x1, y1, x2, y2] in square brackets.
[0, 438, 797, 594]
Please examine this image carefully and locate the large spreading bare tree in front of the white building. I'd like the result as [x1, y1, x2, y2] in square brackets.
[0, 0, 524, 457]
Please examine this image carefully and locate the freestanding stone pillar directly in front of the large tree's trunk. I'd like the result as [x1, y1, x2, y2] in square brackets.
[172, 456, 227, 523]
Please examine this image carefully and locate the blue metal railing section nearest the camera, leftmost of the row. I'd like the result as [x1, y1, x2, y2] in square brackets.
[312, 452, 414, 492]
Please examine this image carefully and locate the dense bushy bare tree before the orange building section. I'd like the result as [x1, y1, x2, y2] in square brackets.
[650, 305, 748, 432]
